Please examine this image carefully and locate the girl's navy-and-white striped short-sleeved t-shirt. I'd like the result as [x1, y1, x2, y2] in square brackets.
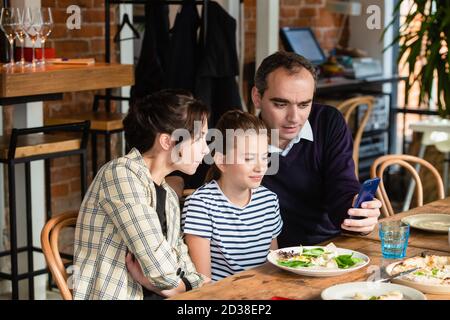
[182, 181, 283, 281]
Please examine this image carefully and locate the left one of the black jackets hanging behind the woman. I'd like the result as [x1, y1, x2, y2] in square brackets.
[132, 0, 200, 100]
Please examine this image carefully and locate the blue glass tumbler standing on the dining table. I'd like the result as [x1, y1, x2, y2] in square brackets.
[379, 221, 409, 259]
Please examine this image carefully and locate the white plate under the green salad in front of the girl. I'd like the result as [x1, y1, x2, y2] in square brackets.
[267, 246, 370, 277]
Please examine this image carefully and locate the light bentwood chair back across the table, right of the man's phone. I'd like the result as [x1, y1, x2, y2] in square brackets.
[370, 154, 445, 217]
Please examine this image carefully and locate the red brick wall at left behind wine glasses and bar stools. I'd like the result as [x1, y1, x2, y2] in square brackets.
[42, 0, 118, 214]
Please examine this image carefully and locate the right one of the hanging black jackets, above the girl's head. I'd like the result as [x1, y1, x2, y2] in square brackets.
[195, 1, 242, 127]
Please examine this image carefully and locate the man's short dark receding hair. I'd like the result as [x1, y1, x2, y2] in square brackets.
[255, 51, 317, 96]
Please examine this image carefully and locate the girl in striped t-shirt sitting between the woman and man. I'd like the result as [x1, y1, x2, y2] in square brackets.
[182, 110, 282, 281]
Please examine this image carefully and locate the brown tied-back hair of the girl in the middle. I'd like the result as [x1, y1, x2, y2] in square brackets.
[205, 110, 267, 182]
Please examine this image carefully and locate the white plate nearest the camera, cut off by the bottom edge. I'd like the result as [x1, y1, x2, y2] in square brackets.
[321, 282, 427, 300]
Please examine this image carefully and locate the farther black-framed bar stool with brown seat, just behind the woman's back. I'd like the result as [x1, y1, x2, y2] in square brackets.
[45, 95, 130, 176]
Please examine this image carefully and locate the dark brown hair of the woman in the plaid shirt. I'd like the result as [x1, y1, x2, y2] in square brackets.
[123, 90, 208, 153]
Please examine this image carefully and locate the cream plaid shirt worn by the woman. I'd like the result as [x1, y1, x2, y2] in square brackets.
[72, 149, 204, 299]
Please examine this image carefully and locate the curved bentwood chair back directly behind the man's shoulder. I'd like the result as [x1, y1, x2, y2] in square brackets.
[336, 96, 375, 177]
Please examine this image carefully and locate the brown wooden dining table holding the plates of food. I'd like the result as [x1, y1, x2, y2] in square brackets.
[172, 197, 450, 300]
